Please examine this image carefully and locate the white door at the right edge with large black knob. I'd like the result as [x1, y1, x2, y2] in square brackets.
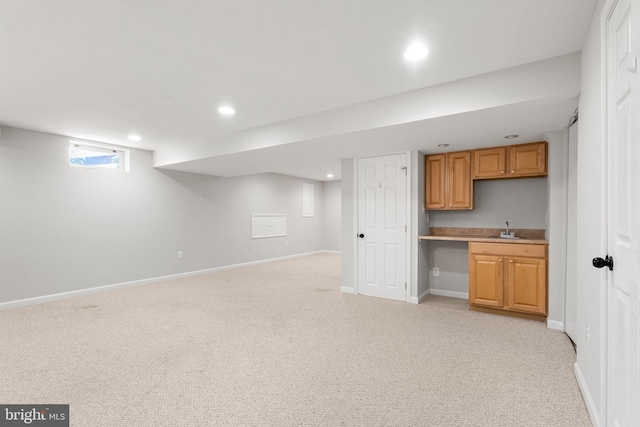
[607, 0, 640, 427]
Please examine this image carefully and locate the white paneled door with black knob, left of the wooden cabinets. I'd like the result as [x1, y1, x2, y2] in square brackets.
[358, 154, 408, 300]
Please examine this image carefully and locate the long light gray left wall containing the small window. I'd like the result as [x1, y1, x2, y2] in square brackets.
[0, 127, 334, 303]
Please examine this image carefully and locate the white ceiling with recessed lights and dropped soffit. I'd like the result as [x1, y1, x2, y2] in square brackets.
[0, 0, 596, 180]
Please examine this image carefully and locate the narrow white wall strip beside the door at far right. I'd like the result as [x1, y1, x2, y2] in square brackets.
[576, 0, 611, 425]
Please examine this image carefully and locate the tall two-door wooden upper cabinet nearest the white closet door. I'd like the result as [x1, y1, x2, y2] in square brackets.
[425, 151, 473, 210]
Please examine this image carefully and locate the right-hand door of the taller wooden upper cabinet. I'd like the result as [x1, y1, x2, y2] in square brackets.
[445, 151, 473, 209]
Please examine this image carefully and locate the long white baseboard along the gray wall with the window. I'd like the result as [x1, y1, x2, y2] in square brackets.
[0, 251, 327, 310]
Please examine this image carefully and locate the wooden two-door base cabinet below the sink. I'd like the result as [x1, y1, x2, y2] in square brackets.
[469, 242, 547, 320]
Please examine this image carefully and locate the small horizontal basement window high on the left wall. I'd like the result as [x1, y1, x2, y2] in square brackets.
[69, 141, 129, 172]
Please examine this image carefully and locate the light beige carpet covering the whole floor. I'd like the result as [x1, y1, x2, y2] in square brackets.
[0, 254, 591, 427]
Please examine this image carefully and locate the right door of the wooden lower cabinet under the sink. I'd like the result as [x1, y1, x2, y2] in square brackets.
[506, 257, 547, 314]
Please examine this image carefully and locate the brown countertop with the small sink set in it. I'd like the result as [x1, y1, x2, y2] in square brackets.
[418, 227, 549, 245]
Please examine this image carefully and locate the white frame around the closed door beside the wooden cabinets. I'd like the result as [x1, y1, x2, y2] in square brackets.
[351, 151, 417, 302]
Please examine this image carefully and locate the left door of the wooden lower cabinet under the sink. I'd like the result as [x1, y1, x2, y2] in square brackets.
[469, 254, 504, 308]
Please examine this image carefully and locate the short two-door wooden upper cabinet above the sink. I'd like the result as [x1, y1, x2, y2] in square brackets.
[473, 141, 547, 179]
